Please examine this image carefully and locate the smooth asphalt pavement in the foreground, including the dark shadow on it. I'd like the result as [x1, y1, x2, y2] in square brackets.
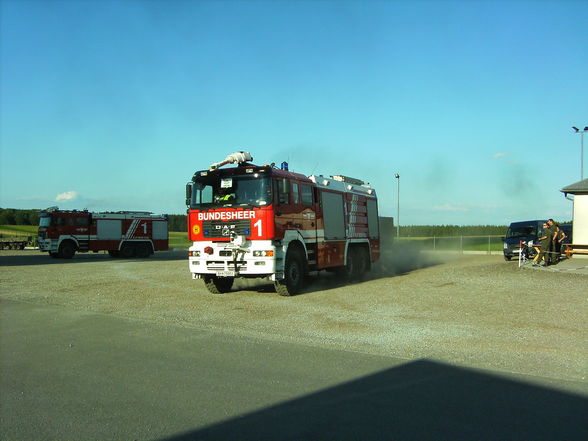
[0, 300, 588, 441]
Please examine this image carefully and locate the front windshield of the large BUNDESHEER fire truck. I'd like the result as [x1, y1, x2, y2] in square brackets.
[190, 173, 272, 209]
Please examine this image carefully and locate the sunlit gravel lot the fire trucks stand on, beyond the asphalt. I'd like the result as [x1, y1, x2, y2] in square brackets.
[0, 249, 588, 393]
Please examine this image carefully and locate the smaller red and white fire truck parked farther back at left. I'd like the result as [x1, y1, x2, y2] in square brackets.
[39, 207, 168, 259]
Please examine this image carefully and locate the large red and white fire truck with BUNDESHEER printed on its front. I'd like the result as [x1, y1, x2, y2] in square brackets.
[186, 152, 380, 296]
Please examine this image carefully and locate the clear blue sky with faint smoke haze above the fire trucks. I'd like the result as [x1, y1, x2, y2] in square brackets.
[0, 0, 588, 225]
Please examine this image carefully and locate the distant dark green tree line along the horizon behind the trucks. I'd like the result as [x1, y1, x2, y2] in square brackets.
[0, 208, 507, 237]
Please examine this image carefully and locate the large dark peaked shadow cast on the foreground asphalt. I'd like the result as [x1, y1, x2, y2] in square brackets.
[161, 360, 588, 441]
